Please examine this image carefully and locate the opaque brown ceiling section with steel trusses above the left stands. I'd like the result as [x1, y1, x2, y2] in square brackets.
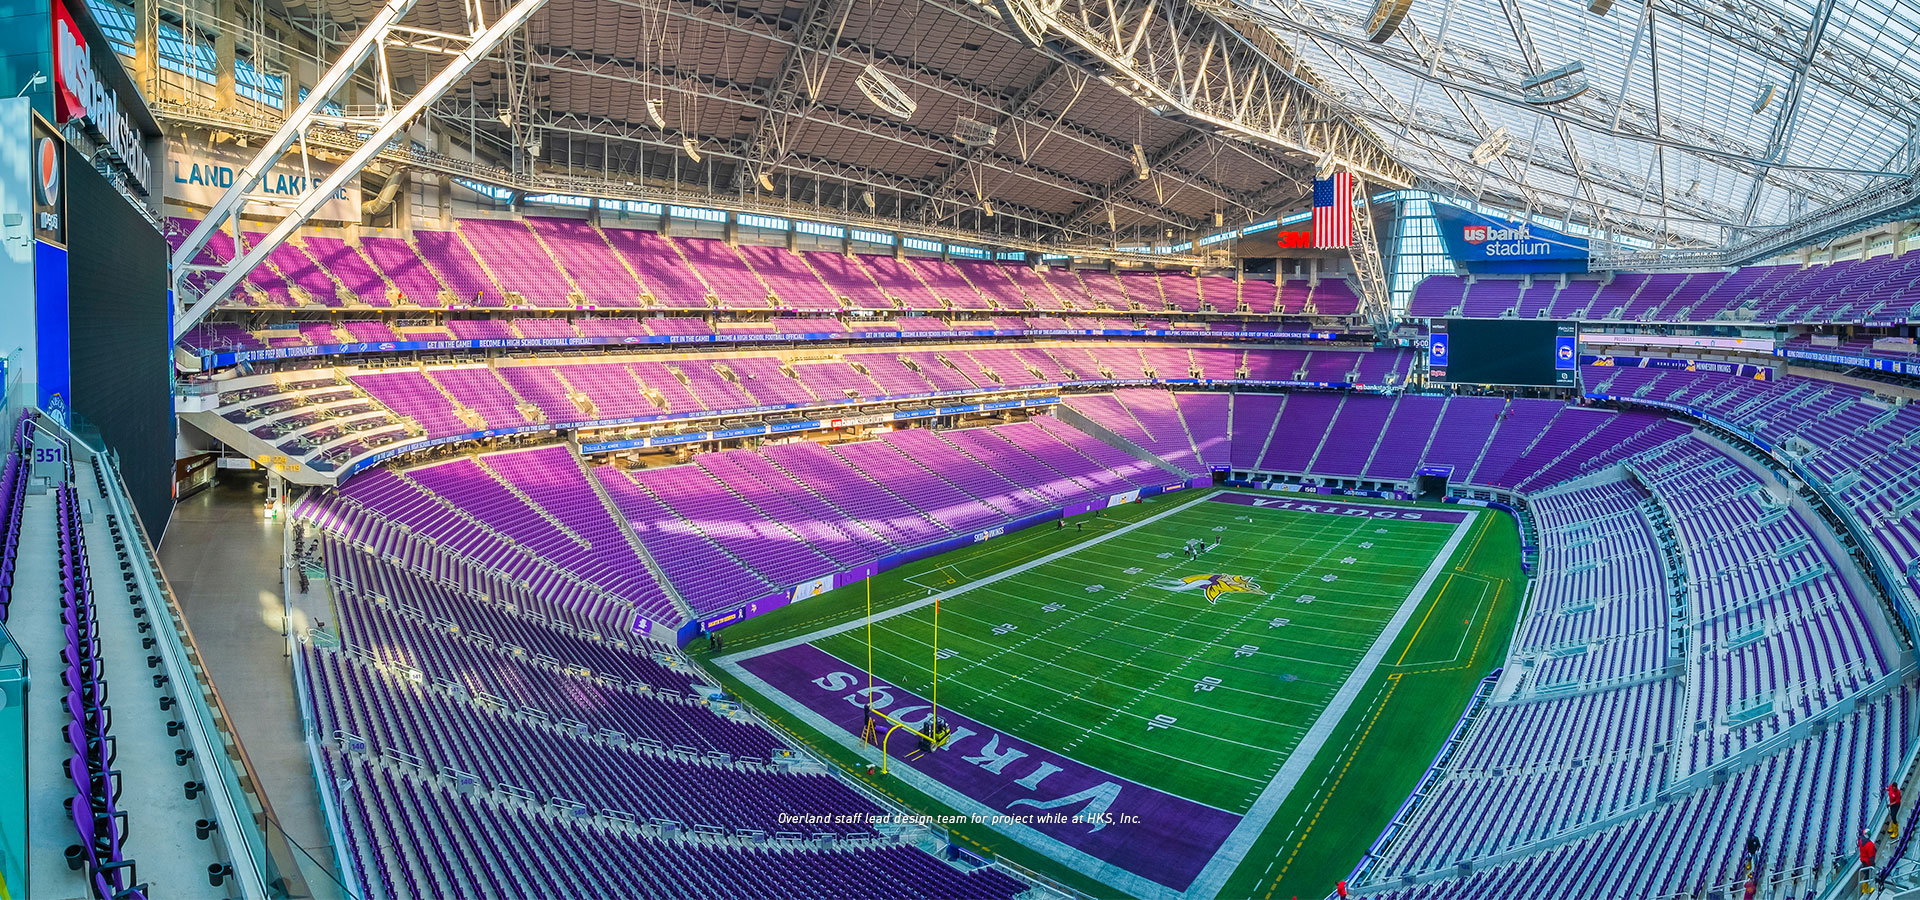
[263, 0, 1411, 246]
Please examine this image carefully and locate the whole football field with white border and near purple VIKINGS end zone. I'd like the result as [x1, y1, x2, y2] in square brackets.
[718, 491, 1520, 898]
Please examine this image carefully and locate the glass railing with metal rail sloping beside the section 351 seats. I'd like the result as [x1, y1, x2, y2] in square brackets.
[51, 422, 355, 900]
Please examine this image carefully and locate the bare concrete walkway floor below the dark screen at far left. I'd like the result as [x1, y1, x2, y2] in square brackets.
[159, 472, 334, 882]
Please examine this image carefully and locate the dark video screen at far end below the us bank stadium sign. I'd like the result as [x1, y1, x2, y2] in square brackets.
[1427, 319, 1580, 388]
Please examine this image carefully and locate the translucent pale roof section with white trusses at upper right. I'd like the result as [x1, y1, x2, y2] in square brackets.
[1196, 0, 1920, 248]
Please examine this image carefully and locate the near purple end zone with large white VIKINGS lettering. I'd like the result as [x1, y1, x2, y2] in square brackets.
[739, 645, 1240, 890]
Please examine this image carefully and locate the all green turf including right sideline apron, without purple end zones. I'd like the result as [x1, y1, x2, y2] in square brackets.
[698, 495, 1523, 898]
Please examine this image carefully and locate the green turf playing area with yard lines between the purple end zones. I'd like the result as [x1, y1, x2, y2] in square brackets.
[814, 501, 1455, 812]
